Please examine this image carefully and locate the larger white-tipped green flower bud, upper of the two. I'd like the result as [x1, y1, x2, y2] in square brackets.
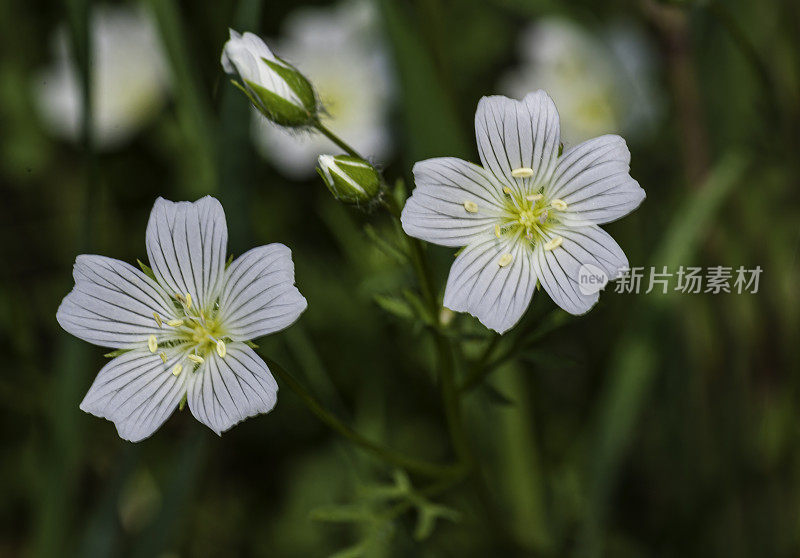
[221, 29, 319, 127]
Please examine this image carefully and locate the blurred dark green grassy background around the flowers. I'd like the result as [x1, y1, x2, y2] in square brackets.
[0, 0, 800, 557]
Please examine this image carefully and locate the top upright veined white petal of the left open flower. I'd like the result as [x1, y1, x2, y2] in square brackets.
[147, 196, 228, 308]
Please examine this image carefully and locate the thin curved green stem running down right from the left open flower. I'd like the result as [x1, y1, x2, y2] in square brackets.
[262, 355, 461, 477]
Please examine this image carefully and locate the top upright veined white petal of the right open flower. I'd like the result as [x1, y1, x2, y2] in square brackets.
[475, 90, 561, 188]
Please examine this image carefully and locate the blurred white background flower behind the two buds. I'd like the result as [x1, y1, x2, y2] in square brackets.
[253, 2, 391, 179]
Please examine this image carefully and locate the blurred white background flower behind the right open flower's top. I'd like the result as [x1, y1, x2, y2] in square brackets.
[500, 17, 661, 145]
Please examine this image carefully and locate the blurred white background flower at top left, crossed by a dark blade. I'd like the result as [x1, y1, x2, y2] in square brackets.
[34, 6, 169, 149]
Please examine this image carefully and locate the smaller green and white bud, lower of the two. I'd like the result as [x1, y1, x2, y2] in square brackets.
[317, 155, 381, 203]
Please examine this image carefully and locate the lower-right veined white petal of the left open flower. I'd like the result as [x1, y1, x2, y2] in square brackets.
[187, 343, 278, 434]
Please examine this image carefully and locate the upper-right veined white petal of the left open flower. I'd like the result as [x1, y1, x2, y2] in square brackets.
[219, 244, 307, 341]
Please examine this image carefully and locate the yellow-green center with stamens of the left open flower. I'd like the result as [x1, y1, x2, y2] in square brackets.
[147, 293, 230, 376]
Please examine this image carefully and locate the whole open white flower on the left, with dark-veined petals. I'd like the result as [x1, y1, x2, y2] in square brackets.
[57, 196, 306, 441]
